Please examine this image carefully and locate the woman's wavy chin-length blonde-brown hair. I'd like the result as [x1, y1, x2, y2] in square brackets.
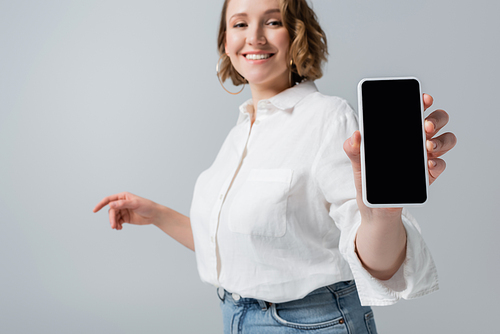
[217, 0, 328, 86]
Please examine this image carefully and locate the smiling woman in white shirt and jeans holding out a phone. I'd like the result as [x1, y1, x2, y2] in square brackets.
[94, 0, 456, 333]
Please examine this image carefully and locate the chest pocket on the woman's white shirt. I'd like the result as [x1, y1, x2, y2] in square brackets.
[229, 169, 293, 238]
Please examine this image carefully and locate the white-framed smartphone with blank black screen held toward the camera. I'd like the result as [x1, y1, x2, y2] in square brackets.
[358, 77, 429, 208]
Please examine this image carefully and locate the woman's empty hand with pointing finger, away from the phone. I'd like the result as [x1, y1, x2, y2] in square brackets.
[93, 192, 160, 230]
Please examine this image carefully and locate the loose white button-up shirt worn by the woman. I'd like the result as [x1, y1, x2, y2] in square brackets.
[190, 82, 438, 305]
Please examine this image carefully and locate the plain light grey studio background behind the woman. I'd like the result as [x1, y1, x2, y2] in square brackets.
[0, 0, 500, 333]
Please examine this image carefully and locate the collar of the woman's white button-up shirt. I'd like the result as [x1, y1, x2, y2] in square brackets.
[237, 81, 318, 124]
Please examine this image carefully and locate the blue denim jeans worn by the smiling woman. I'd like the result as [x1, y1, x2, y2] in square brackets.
[218, 281, 377, 334]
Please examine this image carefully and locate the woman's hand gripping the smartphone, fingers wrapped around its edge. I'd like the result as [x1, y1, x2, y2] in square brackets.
[344, 94, 457, 214]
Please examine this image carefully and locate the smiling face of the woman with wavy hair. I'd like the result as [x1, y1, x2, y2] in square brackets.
[225, 0, 290, 86]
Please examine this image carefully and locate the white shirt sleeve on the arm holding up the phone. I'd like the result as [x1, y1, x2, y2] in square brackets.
[312, 102, 438, 306]
